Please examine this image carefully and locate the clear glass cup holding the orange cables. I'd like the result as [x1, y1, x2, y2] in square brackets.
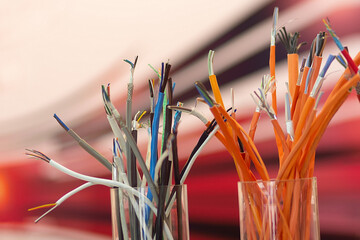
[238, 178, 320, 240]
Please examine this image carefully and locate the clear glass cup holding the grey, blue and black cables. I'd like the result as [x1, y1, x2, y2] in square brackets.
[110, 185, 190, 240]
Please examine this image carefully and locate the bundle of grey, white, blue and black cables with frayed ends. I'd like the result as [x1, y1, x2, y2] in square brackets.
[26, 57, 231, 239]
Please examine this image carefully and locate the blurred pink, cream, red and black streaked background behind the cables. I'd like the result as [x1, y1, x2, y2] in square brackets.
[0, 0, 360, 240]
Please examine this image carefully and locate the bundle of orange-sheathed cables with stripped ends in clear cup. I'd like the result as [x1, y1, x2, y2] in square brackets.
[195, 8, 360, 239]
